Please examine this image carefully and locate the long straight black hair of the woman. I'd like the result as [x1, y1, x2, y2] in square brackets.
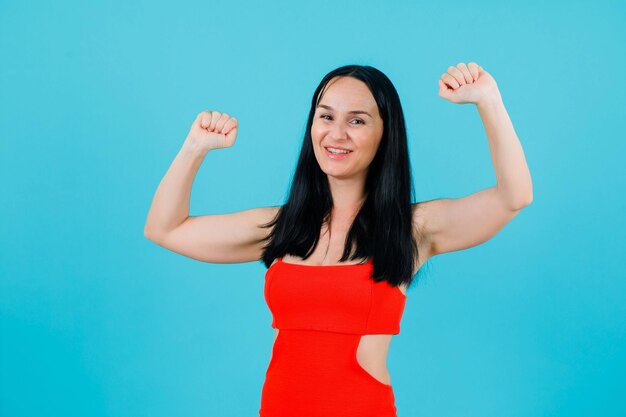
[262, 65, 418, 286]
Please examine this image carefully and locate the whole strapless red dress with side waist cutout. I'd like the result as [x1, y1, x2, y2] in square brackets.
[259, 258, 406, 417]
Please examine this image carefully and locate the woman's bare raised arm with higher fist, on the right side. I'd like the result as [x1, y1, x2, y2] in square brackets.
[414, 62, 533, 256]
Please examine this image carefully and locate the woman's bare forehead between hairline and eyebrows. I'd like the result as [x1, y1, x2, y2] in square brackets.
[319, 76, 377, 111]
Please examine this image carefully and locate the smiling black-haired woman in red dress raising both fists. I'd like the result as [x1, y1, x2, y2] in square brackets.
[145, 62, 532, 417]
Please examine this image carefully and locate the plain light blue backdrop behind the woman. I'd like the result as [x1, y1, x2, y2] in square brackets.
[0, 0, 626, 417]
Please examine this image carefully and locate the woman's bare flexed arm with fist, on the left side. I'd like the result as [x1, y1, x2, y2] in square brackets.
[144, 111, 280, 263]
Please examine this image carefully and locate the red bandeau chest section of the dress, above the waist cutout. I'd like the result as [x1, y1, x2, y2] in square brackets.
[264, 258, 406, 334]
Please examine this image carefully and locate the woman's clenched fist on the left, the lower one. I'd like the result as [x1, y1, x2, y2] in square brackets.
[187, 110, 238, 151]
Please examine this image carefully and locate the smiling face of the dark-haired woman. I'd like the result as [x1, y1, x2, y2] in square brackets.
[311, 76, 383, 178]
